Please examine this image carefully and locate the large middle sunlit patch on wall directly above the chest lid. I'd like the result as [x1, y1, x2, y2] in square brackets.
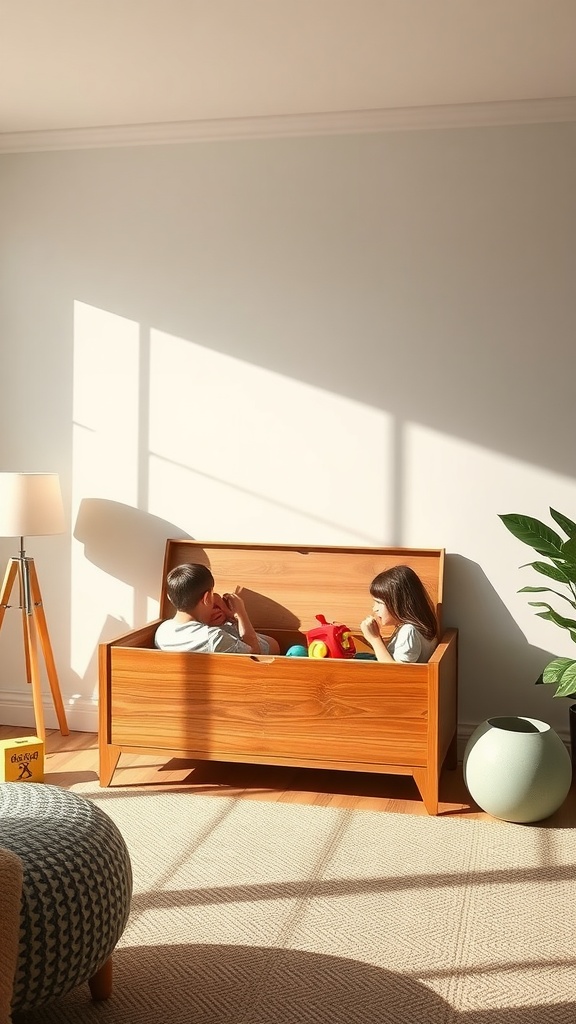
[149, 331, 394, 545]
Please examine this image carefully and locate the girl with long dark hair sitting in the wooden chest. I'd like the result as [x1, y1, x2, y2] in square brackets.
[360, 565, 438, 662]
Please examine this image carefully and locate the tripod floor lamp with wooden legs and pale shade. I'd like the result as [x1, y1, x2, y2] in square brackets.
[0, 473, 69, 740]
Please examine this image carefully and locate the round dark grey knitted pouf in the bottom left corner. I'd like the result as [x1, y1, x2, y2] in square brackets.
[0, 782, 132, 1013]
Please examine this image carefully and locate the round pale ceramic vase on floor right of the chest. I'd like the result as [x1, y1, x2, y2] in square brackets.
[463, 717, 572, 822]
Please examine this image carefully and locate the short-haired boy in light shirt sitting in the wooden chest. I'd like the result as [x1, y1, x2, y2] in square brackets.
[154, 562, 280, 654]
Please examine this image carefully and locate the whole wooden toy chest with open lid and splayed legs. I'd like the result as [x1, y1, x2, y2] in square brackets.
[99, 540, 457, 814]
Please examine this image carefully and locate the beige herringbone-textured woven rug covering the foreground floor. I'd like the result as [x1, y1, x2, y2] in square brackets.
[12, 784, 576, 1024]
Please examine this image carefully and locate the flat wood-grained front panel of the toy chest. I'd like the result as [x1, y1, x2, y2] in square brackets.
[111, 647, 429, 767]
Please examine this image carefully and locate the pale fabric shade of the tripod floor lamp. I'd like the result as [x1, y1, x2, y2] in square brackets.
[0, 473, 66, 537]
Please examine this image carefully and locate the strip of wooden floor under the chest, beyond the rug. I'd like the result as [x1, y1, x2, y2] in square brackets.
[0, 726, 576, 827]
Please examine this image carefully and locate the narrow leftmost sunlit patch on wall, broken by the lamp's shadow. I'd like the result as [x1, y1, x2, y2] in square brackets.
[71, 302, 140, 677]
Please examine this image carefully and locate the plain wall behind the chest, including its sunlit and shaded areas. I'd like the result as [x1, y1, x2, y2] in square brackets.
[0, 124, 576, 735]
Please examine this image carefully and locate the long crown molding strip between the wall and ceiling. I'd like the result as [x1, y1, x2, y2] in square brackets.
[0, 96, 576, 154]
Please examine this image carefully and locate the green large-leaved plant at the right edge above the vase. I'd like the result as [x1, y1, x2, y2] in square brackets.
[499, 508, 576, 761]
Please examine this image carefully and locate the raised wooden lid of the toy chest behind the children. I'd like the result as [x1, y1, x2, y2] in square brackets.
[160, 540, 444, 632]
